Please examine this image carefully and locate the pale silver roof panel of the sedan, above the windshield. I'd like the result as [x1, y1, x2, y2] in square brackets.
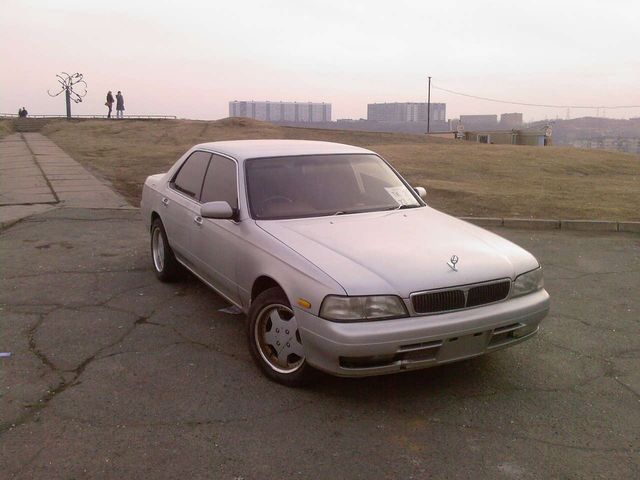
[193, 140, 373, 161]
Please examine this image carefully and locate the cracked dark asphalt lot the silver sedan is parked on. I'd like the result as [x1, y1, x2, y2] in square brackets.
[0, 208, 640, 479]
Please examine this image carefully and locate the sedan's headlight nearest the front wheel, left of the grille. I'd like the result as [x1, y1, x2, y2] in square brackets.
[320, 295, 409, 322]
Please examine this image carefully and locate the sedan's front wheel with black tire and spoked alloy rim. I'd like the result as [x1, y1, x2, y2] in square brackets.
[247, 287, 316, 387]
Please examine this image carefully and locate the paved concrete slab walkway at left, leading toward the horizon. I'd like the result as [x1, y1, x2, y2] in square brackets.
[0, 133, 131, 226]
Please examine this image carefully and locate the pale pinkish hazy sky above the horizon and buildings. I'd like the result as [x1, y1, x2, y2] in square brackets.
[0, 0, 640, 121]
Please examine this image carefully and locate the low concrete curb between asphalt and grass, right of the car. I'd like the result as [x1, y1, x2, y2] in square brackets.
[459, 217, 640, 233]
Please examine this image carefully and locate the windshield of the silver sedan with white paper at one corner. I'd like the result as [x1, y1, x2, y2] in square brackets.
[245, 154, 421, 220]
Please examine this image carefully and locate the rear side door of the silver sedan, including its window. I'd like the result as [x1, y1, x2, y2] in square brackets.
[161, 151, 211, 267]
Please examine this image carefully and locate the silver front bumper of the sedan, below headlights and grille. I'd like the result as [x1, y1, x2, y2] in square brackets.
[295, 289, 549, 377]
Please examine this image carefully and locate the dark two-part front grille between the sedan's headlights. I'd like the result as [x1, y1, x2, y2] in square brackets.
[411, 280, 511, 313]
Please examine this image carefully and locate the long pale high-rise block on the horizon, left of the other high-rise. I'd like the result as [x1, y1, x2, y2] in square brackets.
[229, 100, 331, 123]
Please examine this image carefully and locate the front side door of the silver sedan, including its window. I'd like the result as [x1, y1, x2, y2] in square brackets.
[194, 154, 243, 303]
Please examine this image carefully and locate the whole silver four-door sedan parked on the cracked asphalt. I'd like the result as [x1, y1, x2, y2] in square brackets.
[141, 140, 549, 385]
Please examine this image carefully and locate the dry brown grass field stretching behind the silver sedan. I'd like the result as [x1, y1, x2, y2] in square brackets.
[43, 119, 640, 220]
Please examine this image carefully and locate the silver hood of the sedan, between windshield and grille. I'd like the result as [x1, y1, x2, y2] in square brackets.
[256, 207, 538, 298]
